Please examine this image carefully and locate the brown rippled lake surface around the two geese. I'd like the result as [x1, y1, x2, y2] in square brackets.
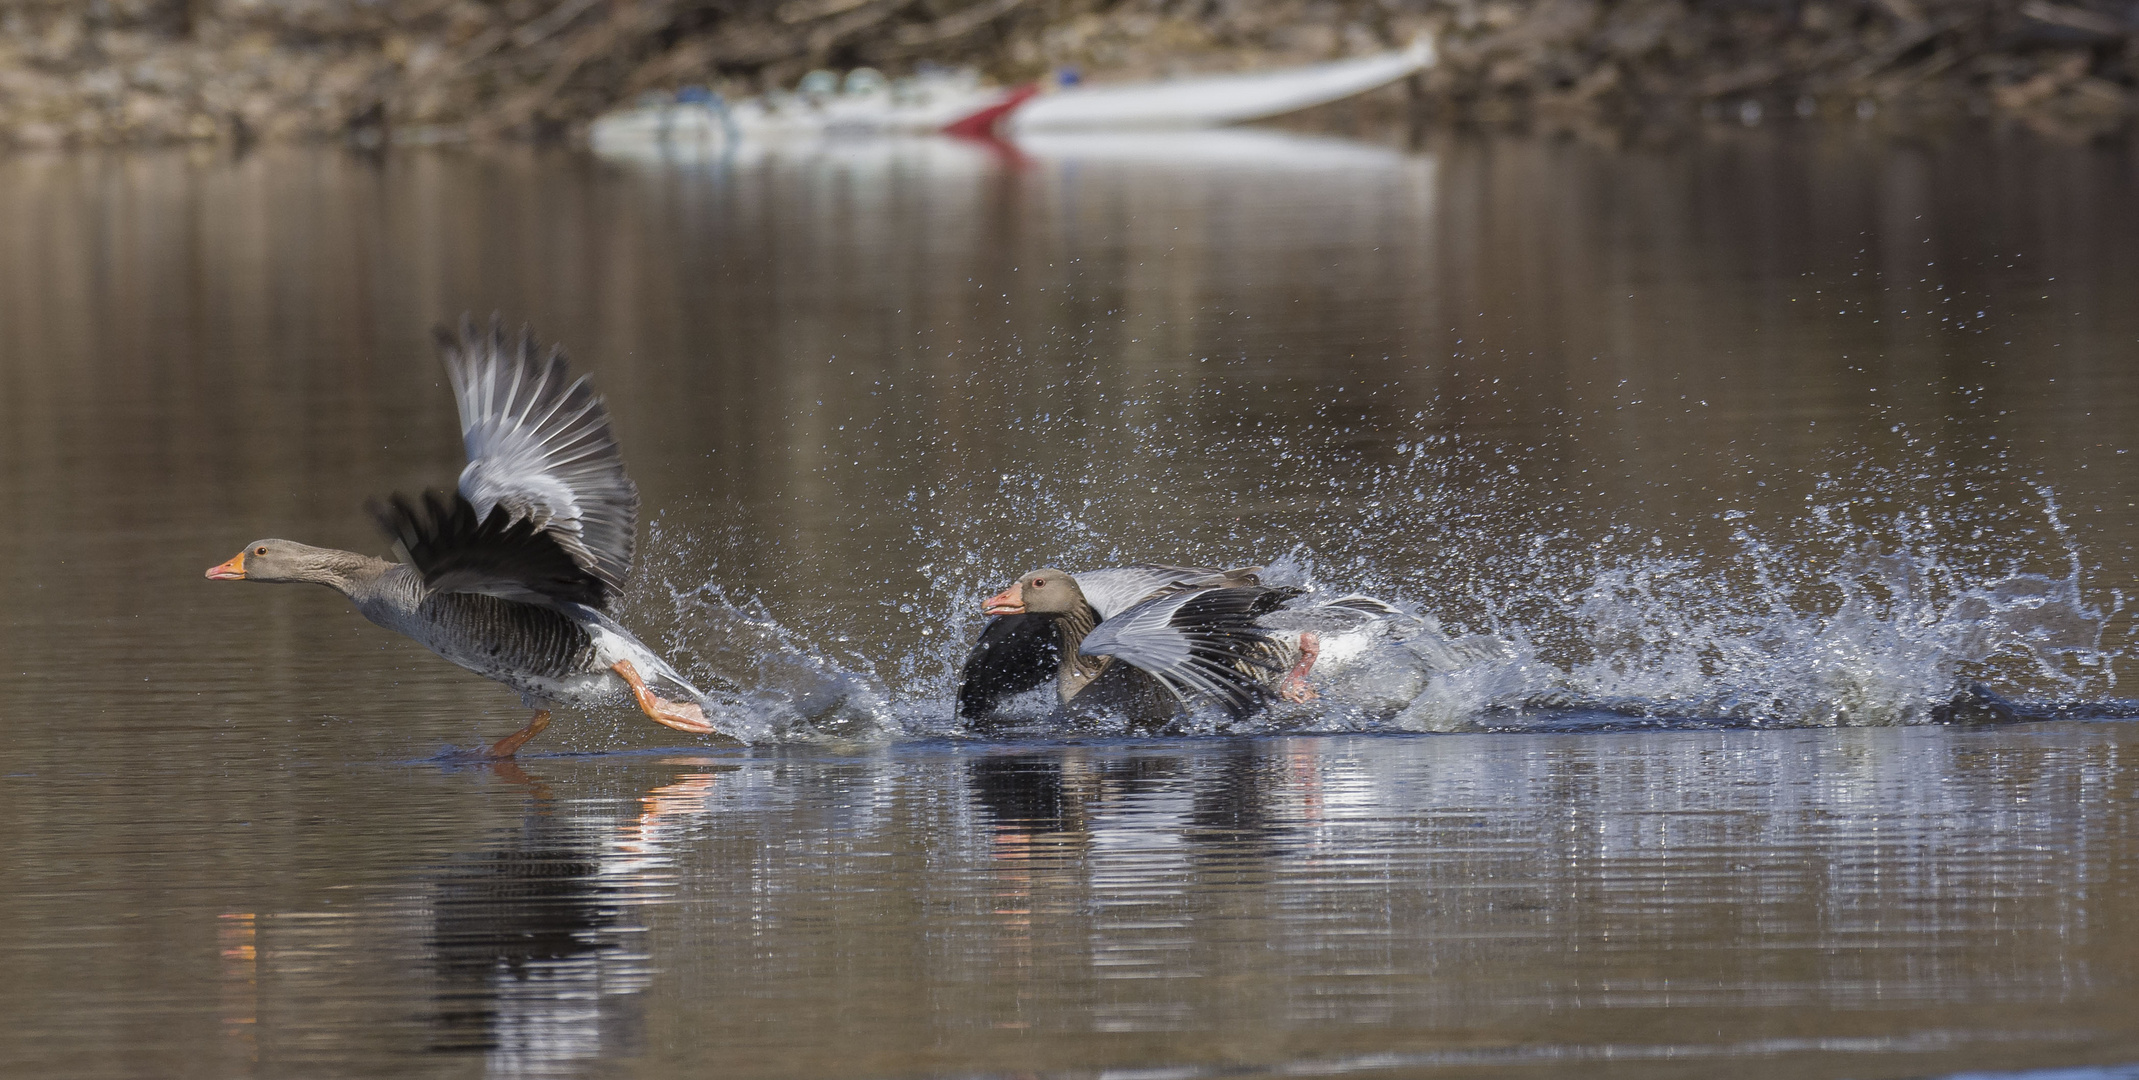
[0, 128, 2139, 1080]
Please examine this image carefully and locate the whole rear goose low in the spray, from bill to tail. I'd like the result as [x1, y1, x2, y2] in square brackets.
[958, 565, 1469, 725]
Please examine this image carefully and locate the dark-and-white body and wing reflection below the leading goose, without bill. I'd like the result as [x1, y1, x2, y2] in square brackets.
[428, 761, 735, 1076]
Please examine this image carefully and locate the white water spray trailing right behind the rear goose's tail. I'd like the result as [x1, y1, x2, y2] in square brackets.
[1437, 494, 2124, 729]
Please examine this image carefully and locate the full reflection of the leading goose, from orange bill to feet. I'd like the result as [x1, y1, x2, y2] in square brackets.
[214, 757, 736, 1076]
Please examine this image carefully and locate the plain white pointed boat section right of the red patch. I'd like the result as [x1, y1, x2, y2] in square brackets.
[1003, 36, 1435, 133]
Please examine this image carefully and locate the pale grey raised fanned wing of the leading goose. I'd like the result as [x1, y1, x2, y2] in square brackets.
[438, 319, 640, 592]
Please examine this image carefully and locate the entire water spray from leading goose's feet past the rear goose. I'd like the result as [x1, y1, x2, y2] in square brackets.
[633, 455, 2126, 742]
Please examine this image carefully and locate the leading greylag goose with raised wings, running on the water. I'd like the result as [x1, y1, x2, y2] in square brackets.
[207, 319, 714, 757]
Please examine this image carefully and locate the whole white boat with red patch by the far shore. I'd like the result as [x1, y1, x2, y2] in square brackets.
[588, 36, 1435, 154]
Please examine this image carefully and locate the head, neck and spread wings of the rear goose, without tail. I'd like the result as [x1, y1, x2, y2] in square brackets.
[958, 565, 1301, 723]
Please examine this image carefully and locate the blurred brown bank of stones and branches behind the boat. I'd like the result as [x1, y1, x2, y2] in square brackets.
[0, 0, 2139, 145]
